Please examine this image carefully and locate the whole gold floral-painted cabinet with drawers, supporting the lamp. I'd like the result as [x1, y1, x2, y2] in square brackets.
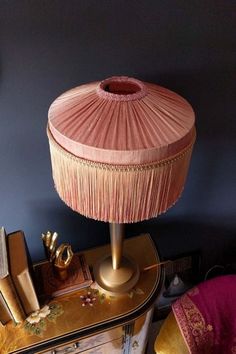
[0, 235, 163, 354]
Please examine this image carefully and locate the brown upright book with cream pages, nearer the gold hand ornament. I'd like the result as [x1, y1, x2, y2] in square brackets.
[7, 231, 40, 315]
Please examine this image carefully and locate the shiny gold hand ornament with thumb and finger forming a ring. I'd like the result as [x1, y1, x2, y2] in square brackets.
[42, 231, 73, 280]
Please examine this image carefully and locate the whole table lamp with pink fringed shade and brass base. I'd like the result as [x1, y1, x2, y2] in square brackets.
[47, 76, 196, 293]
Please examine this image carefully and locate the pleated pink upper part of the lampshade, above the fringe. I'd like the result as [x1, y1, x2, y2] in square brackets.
[49, 76, 195, 165]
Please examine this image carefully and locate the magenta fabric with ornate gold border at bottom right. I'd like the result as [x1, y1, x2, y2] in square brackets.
[172, 275, 236, 354]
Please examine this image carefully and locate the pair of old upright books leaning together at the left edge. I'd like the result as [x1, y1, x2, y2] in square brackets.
[0, 227, 40, 325]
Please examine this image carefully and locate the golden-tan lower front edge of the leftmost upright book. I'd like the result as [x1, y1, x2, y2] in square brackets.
[0, 275, 26, 323]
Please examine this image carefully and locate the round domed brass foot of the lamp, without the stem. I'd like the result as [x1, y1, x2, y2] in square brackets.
[94, 256, 140, 294]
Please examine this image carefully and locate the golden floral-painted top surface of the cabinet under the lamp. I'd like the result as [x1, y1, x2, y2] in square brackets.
[0, 235, 162, 354]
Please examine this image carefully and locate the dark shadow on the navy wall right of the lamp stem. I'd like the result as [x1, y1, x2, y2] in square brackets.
[127, 217, 236, 278]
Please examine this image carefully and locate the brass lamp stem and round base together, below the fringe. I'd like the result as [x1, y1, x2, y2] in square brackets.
[94, 223, 140, 294]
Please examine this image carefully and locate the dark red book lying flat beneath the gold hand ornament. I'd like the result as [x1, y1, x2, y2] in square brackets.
[35, 254, 93, 298]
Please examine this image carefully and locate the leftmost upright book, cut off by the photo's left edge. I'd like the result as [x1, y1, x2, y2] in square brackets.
[0, 227, 25, 324]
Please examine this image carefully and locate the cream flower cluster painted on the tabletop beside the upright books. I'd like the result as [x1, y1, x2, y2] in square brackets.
[24, 302, 64, 336]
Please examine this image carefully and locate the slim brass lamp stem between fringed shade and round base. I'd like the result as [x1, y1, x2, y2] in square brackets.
[109, 223, 125, 269]
